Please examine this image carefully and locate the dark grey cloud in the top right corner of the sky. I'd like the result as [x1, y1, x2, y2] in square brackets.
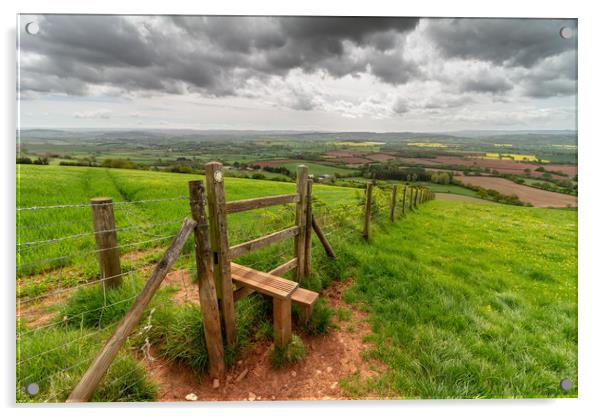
[426, 19, 576, 68]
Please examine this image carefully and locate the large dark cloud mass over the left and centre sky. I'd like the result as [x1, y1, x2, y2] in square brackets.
[21, 15, 418, 96]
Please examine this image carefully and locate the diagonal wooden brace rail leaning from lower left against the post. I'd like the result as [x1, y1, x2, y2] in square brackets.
[67, 219, 196, 403]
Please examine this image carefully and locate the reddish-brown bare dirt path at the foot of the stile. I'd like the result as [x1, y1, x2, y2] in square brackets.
[144, 270, 385, 401]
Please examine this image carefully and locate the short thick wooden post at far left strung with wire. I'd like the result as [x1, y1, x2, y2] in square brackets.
[90, 197, 122, 287]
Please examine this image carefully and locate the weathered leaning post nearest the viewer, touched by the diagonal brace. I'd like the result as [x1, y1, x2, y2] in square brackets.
[188, 181, 226, 381]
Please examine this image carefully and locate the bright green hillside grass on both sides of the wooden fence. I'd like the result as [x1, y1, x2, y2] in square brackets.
[17, 165, 578, 401]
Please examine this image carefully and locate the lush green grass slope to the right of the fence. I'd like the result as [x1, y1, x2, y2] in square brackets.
[339, 200, 577, 398]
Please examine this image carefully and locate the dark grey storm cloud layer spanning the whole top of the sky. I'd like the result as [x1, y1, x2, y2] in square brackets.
[20, 15, 576, 107]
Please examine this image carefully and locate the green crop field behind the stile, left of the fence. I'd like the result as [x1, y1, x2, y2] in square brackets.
[17, 165, 355, 275]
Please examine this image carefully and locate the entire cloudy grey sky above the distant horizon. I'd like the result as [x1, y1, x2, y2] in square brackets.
[18, 15, 577, 131]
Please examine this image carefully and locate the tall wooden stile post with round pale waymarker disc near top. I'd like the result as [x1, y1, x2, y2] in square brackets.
[205, 162, 236, 345]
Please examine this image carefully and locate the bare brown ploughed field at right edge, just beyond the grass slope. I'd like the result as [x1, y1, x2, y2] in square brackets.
[457, 176, 577, 208]
